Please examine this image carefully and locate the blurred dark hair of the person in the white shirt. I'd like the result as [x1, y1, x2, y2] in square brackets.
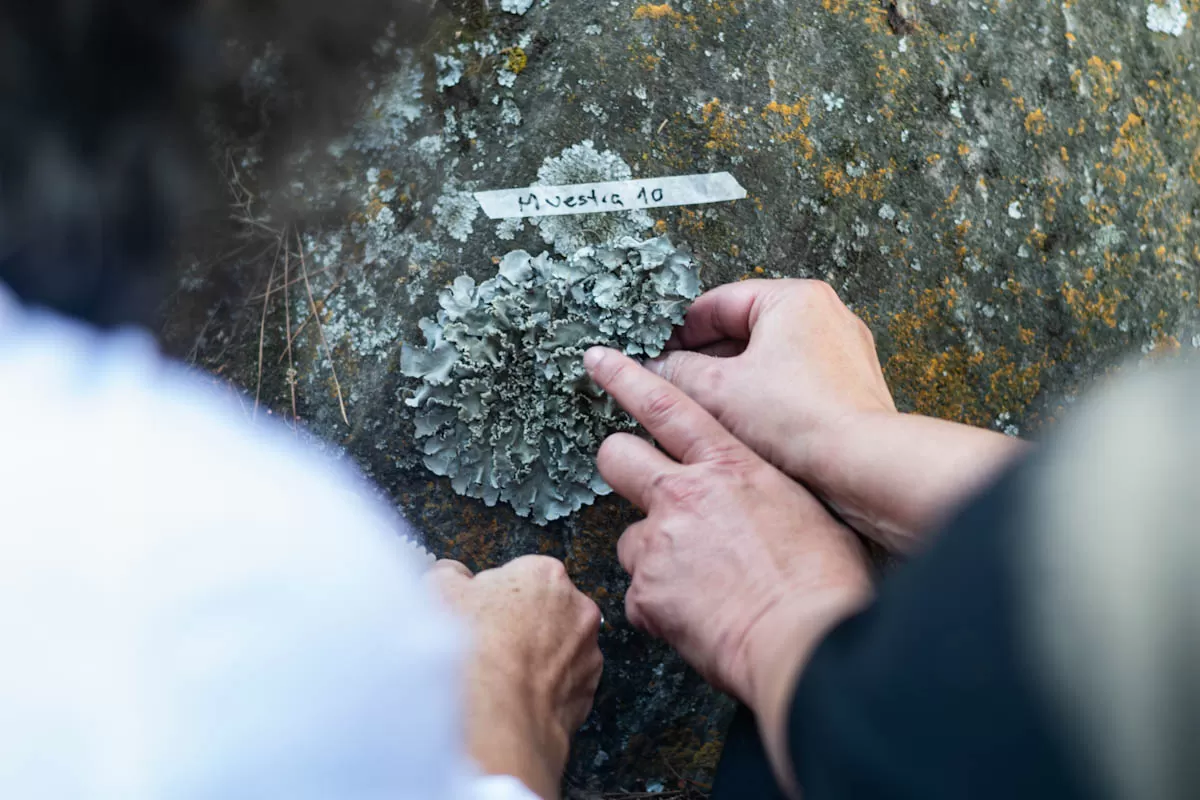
[0, 0, 429, 326]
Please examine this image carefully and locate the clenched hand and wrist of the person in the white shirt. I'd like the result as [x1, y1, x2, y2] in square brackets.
[426, 555, 604, 800]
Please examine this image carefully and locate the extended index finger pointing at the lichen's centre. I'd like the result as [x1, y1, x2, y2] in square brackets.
[583, 348, 740, 464]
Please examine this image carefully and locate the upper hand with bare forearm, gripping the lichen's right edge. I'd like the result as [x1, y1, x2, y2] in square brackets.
[647, 281, 1026, 551]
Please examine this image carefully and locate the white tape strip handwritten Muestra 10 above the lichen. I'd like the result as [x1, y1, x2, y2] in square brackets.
[475, 173, 746, 219]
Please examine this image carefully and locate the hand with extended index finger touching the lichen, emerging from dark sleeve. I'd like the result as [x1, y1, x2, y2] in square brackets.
[584, 348, 871, 796]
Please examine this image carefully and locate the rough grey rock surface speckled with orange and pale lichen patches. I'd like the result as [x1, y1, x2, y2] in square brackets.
[164, 0, 1200, 796]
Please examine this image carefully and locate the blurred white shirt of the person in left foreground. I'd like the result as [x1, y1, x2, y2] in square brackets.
[0, 285, 533, 800]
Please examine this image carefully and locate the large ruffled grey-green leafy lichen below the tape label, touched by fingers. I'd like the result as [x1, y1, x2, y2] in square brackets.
[401, 237, 700, 524]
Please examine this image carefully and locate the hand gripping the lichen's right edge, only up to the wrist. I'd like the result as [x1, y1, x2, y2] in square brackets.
[647, 281, 896, 475]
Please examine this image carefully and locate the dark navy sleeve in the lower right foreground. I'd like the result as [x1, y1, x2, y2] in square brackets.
[788, 468, 1091, 800]
